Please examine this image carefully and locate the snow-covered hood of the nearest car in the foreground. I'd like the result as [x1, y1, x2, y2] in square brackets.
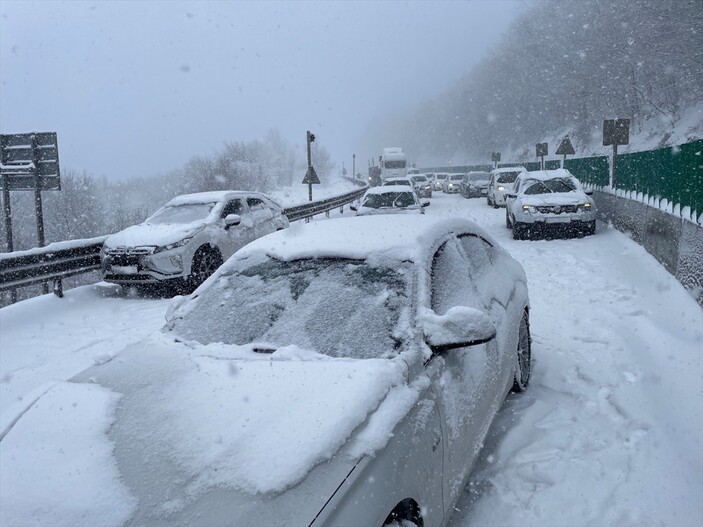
[3, 334, 407, 526]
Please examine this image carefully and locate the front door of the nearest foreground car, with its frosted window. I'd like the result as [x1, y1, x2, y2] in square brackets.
[426, 239, 498, 507]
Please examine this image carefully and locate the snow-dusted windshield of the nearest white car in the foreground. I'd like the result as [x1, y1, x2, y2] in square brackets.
[167, 258, 411, 359]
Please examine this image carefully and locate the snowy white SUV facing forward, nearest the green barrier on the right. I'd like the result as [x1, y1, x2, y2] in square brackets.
[505, 168, 596, 240]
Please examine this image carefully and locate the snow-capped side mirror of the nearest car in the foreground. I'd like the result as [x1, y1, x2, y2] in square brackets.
[420, 306, 496, 353]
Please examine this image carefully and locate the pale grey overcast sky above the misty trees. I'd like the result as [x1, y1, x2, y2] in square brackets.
[0, 0, 527, 179]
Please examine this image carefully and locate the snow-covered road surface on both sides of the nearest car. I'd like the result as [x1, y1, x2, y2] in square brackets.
[0, 188, 703, 527]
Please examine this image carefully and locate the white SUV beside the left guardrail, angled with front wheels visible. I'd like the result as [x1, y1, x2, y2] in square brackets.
[101, 191, 288, 290]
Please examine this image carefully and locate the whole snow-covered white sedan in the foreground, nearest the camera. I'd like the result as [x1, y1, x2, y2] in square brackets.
[2, 216, 531, 527]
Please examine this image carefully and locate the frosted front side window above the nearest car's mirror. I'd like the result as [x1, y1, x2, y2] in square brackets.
[431, 241, 479, 315]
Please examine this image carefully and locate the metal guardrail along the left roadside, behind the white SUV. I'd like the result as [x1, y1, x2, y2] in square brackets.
[0, 187, 366, 303]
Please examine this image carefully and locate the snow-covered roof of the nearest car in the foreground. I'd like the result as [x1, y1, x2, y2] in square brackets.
[234, 214, 498, 269]
